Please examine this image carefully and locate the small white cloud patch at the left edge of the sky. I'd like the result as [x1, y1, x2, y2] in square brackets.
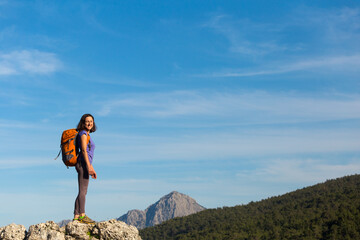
[0, 50, 62, 75]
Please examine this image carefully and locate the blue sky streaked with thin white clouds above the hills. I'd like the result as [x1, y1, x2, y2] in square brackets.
[0, 0, 360, 229]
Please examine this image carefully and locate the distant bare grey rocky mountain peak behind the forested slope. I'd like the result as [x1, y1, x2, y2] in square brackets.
[117, 191, 206, 229]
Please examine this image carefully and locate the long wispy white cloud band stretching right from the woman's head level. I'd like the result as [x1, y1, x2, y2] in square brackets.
[98, 91, 360, 124]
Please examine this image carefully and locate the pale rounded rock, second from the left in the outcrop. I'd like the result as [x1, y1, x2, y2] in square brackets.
[26, 221, 65, 240]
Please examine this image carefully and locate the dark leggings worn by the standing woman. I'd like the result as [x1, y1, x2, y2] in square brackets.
[74, 159, 89, 215]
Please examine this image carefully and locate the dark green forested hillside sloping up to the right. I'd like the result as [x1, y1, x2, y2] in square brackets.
[140, 175, 360, 240]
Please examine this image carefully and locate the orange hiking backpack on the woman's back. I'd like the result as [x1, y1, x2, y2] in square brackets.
[55, 128, 90, 168]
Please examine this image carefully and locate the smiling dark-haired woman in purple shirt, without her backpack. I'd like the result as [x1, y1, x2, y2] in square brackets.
[74, 114, 97, 223]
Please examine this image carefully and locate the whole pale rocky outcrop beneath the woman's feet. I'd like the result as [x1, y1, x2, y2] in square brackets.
[0, 219, 141, 240]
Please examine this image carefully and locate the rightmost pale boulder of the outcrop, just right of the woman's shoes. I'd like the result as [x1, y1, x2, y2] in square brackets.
[93, 219, 141, 240]
